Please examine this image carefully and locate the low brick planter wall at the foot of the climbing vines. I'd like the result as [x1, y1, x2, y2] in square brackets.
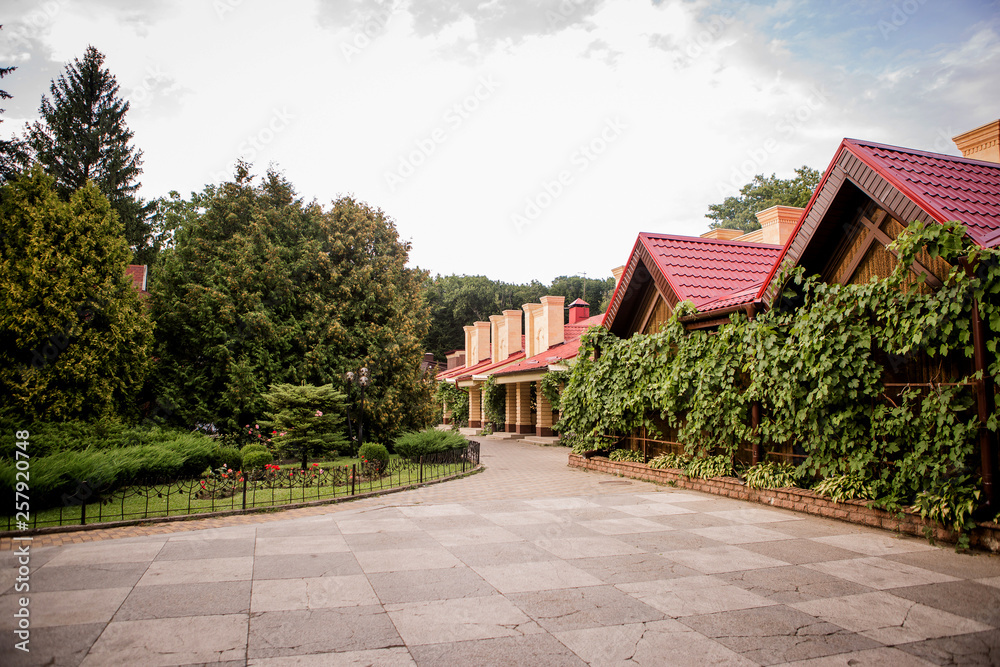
[569, 454, 1000, 552]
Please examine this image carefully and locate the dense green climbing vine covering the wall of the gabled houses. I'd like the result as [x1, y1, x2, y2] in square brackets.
[558, 223, 1000, 536]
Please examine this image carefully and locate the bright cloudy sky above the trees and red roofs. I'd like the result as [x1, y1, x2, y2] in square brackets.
[0, 0, 1000, 282]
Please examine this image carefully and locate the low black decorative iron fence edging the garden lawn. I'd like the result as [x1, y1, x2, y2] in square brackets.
[5, 442, 479, 531]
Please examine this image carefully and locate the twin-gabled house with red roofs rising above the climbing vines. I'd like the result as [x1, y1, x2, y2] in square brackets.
[603, 121, 1000, 506]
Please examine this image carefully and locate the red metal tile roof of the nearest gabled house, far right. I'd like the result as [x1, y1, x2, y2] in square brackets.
[838, 139, 1000, 248]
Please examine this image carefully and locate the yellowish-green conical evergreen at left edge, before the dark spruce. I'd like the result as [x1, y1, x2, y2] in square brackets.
[0, 166, 152, 420]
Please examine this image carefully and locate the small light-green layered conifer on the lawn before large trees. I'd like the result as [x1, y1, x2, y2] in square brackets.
[263, 384, 348, 470]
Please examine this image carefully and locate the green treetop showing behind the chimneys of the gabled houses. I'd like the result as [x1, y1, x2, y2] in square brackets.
[705, 165, 822, 232]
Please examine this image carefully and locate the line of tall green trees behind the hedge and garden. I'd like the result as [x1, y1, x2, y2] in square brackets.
[0, 41, 816, 440]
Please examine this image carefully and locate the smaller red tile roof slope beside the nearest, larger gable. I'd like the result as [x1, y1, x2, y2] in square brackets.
[639, 233, 781, 309]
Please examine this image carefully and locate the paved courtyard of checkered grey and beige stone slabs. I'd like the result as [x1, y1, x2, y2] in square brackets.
[0, 439, 1000, 667]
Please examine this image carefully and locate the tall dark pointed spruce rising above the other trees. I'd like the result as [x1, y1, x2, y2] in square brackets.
[27, 46, 153, 263]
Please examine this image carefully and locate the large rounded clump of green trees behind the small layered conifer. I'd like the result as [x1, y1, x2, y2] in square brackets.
[150, 164, 433, 439]
